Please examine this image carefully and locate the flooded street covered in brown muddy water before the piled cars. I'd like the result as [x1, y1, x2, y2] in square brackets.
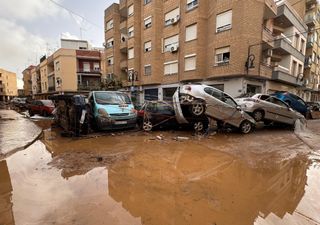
[0, 109, 320, 225]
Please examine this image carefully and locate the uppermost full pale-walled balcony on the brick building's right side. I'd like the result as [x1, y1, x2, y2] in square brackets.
[274, 3, 308, 38]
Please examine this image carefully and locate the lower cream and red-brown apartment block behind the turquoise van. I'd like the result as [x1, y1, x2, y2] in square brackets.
[27, 40, 104, 98]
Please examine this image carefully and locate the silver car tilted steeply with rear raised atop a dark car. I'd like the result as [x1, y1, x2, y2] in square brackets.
[173, 84, 255, 133]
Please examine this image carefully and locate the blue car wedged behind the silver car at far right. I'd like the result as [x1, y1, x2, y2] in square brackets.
[271, 91, 310, 118]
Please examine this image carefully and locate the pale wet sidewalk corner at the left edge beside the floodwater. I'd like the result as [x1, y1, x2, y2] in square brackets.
[0, 109, 42, 160]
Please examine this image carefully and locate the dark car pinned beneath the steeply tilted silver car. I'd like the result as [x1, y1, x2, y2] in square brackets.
[137, 101, 208, 132]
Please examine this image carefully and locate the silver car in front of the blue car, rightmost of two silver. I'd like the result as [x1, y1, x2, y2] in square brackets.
[236, 94, 305, 125]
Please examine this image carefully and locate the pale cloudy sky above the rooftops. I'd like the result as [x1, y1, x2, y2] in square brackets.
[0, 0, 118, 88]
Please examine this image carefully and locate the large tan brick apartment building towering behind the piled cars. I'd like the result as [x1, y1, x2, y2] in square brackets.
[105, 0, 308, 101]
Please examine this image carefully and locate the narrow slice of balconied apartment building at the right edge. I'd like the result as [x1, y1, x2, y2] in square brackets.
[304, 0, 320, 101]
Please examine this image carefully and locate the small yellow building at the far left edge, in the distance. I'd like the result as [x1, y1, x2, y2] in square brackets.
[0, 68, 18, 101]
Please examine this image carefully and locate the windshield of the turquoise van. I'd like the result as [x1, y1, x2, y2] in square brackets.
[94, 92, 131, 105]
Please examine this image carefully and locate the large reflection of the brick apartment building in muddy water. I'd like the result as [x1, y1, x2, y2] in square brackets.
[109, 149, 308, 225]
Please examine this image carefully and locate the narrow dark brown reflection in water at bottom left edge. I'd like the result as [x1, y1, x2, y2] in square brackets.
[0, 160, 14, 225]
